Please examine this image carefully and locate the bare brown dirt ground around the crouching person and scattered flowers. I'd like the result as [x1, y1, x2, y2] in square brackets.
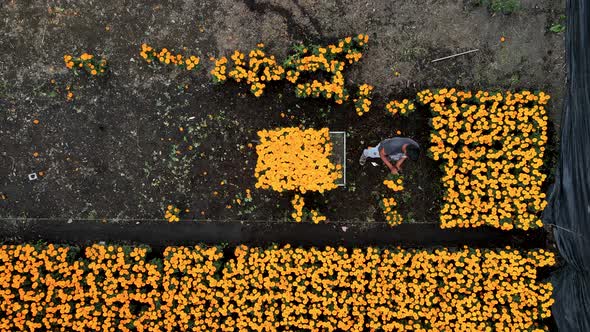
[0, 0, 565, 222]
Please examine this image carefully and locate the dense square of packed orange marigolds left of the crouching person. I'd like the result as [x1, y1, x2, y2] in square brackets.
[254, 127, 342, 194]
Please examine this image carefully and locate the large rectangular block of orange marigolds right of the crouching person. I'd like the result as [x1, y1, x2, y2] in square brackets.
[418, 89, 550, 230]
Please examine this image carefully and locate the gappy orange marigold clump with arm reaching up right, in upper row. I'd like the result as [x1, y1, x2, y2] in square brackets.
[284, 34, 369, 104]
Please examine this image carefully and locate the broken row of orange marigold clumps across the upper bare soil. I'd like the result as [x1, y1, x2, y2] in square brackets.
[64, 38, 415, 116]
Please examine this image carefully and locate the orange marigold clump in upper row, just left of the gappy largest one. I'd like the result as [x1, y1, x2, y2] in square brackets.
[211, 44, 285, 97]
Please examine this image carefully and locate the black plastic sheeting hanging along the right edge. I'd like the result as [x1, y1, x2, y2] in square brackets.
[544, 0, 590, 332]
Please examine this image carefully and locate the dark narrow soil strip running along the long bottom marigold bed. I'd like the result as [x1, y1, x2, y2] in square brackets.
[0, 220, 547, 251]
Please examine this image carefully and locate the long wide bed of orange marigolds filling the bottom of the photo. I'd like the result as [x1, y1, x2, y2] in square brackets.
[0, 245, 555, 332]
